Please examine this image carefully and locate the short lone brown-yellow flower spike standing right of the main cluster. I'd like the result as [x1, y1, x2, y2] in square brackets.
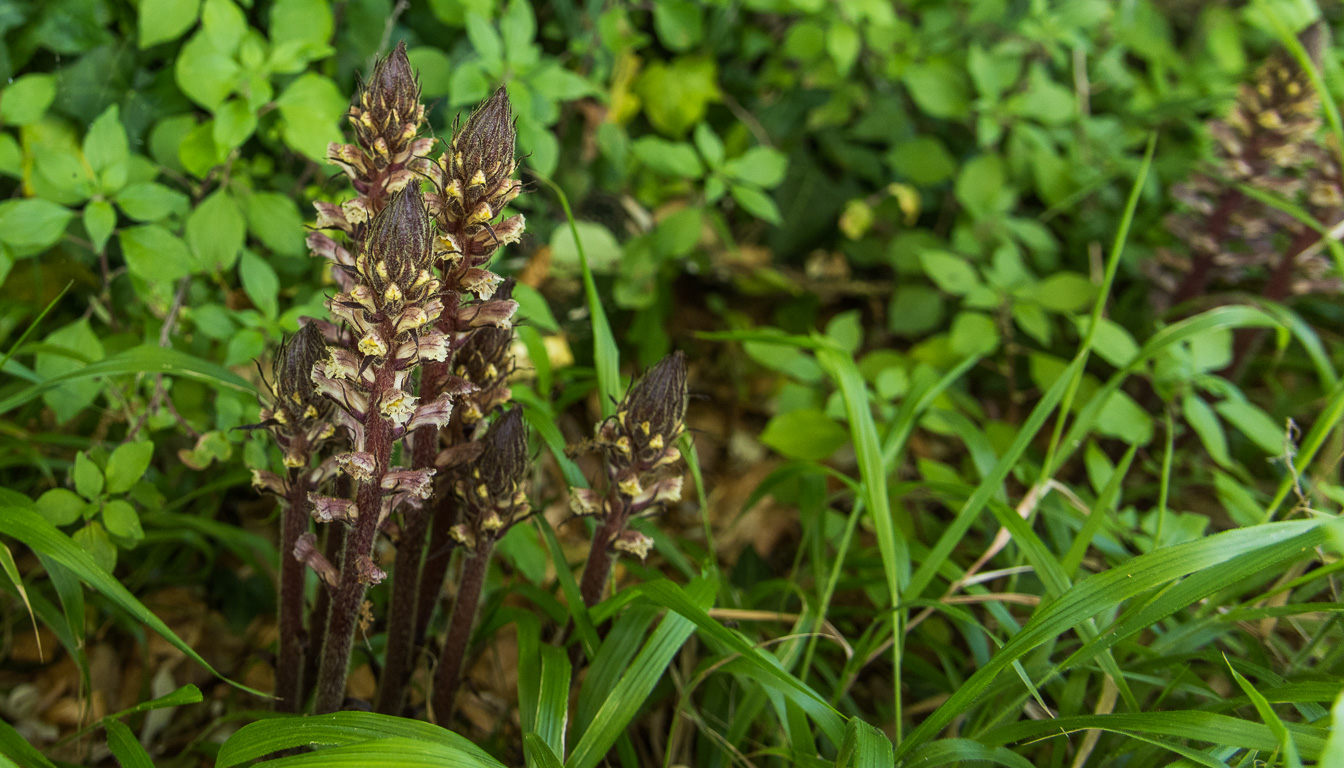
[570, 351, 687, 605]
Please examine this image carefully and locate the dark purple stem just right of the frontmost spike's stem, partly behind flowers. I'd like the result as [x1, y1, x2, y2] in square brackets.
[376, 362, 449, 714]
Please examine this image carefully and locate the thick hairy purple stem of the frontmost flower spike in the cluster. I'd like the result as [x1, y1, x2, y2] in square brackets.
[314, 395, 392, 714]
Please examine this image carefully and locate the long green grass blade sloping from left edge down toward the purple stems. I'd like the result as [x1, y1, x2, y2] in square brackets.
[0, 507, 266, 697]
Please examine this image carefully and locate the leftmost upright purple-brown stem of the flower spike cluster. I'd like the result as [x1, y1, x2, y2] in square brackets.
[276, 467, 309, 713]
